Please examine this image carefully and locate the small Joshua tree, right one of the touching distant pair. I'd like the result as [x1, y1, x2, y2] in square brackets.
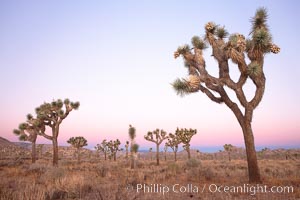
[175, 128, 197, 159]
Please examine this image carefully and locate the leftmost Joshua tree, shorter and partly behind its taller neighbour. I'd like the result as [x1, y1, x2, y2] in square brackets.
[13, 114, 45, 163]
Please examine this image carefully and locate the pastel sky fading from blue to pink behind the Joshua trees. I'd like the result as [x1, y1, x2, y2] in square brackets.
[0, 0, 300, 152]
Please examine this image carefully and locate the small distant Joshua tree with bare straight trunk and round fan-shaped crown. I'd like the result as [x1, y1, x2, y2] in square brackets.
[144, 129, 168, 165]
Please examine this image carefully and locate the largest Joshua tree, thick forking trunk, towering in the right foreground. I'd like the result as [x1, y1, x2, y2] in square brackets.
[173, 8, 280, 182]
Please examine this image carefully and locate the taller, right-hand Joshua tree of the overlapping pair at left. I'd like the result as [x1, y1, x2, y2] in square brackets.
[35, 99, 80, 166]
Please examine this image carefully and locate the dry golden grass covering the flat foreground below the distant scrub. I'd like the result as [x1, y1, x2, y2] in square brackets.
[0, 158, 300, 200]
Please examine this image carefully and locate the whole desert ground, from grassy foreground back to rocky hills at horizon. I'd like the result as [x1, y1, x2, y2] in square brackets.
[0, 138, 300, 200]
